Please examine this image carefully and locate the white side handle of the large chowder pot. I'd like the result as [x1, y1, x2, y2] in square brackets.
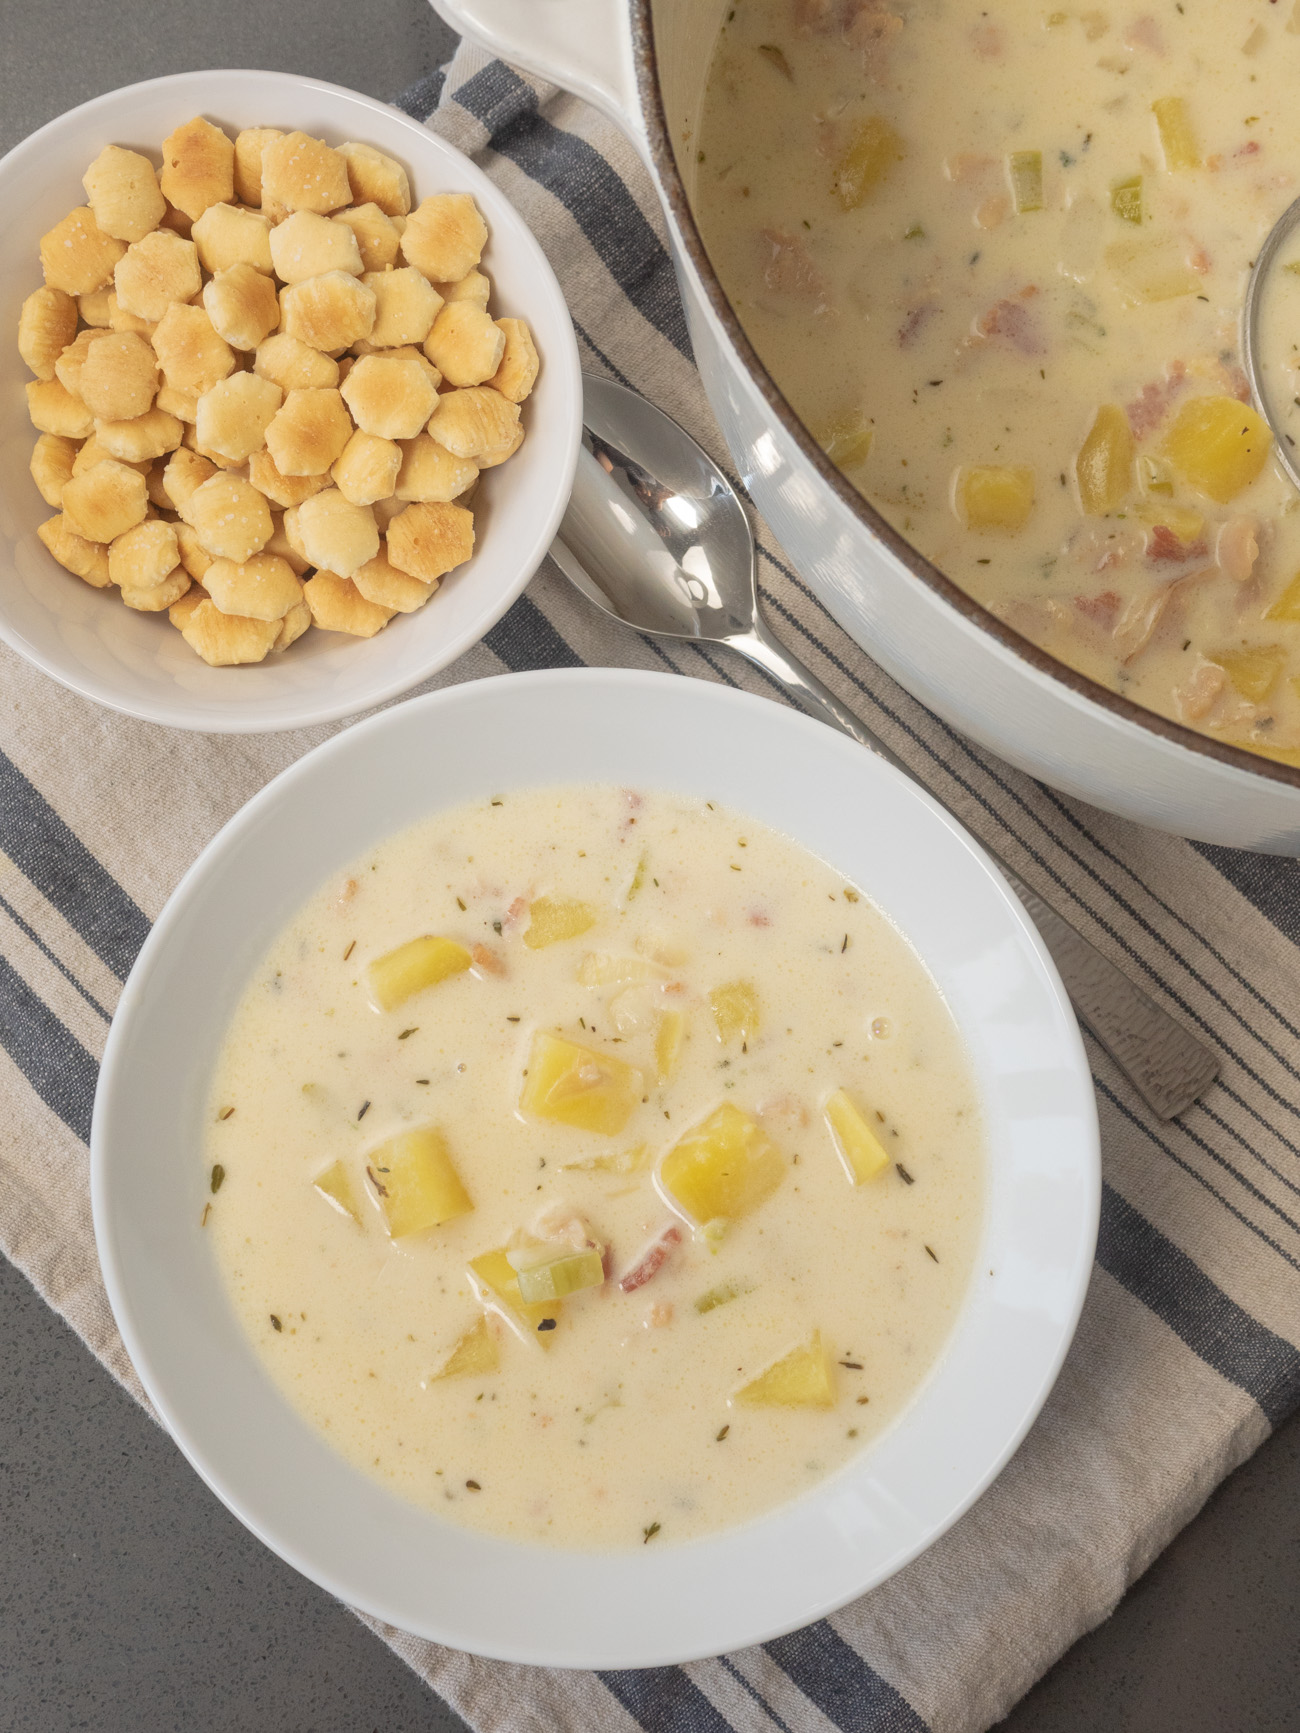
[430, 0, 641, 140]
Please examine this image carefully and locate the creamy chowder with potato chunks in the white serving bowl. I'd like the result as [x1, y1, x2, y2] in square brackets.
[205, 787, 985, 1548]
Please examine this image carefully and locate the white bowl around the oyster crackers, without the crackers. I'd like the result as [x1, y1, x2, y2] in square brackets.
[0, 71, 582, 733]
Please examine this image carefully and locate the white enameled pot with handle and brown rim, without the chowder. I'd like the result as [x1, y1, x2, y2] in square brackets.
[433, 0, 1300, 854]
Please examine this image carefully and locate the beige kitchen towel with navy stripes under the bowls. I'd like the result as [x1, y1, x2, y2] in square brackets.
[0, 37, 1300, 1733]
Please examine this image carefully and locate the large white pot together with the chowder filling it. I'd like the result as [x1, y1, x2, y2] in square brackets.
[439, 0, 1300, 853]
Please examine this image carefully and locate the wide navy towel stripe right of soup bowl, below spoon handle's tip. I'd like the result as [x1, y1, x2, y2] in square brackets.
[1097, 1185, 1300, 1426]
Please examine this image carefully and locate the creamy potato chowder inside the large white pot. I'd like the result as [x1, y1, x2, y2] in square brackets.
[703, 0, 1300, 763]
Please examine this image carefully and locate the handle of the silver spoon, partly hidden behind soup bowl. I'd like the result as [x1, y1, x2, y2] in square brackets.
[725, 620, 1219, 1120]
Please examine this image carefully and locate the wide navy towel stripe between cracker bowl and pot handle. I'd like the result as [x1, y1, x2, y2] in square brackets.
[451, 61, 692, 360]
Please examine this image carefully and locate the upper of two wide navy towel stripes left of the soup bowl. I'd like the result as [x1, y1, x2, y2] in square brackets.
[0, 752, 149, 981]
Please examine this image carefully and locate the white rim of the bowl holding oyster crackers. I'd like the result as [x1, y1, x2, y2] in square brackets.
[0, 68, 582, 735]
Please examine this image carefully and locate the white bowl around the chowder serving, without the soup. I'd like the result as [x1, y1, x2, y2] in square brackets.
[90, 669, 1101, 1667]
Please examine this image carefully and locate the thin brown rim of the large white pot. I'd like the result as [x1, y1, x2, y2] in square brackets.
[629, 0, 1300, 789]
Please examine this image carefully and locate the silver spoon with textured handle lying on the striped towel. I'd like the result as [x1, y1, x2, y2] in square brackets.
[551, 374, 1219, 1120]
